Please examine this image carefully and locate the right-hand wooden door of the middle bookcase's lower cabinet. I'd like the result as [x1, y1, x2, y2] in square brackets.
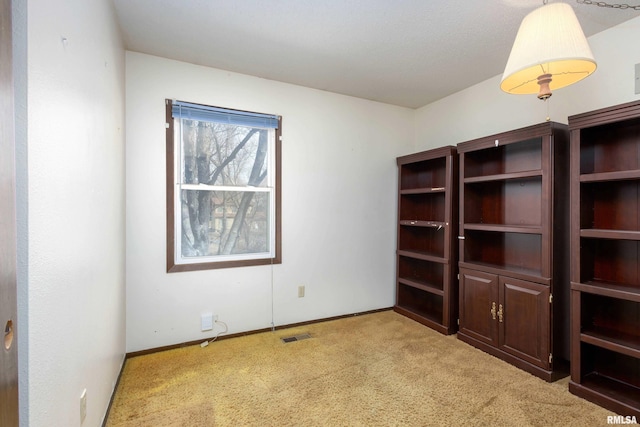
[498, 276, 550, 369]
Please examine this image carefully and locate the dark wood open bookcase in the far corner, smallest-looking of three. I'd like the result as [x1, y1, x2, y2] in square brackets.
[394, 146, 458, 334]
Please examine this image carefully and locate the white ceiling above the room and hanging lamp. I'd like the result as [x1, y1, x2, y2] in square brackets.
[113, 0, 640, 108]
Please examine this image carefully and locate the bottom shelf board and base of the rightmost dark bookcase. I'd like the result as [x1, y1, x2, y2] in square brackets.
[569, 380, 640, 420]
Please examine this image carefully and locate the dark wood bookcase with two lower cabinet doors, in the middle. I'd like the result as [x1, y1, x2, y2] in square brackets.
[457, 122, 569, 381]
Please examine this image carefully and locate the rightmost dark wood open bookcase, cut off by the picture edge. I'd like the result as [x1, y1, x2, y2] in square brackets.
[569, 102, 640, 417]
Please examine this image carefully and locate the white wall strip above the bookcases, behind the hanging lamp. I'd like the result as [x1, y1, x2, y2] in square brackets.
[415, 17, 640, 151]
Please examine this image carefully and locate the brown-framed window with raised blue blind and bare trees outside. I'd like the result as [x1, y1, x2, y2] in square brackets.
[166, 100, 282, 272]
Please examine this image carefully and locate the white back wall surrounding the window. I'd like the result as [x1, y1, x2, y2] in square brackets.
[126, 52, 414, 352]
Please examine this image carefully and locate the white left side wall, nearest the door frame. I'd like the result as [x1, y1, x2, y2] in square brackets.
[24, 0, 125, 427]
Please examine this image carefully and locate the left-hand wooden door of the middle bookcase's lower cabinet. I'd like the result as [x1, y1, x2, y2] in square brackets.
[459, 268, 499, 347]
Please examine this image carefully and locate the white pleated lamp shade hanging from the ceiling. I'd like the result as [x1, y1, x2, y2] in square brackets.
[500, 3, 596, 94]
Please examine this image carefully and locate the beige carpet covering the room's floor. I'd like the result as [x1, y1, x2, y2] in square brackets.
[107, 311, 614, 427]
